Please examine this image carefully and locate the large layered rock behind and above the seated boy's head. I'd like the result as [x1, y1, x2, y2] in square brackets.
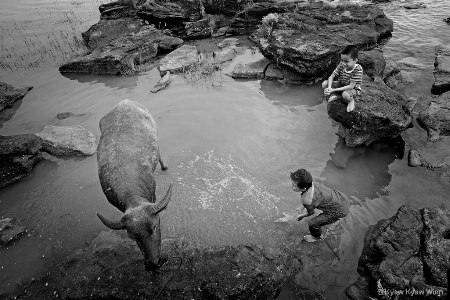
[255, 5, 393, 83]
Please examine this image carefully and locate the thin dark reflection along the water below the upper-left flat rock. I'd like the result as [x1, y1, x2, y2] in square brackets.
[61, 73, 138, 89]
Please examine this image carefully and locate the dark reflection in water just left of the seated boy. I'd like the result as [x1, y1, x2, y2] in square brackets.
[261, 80, 323, 107]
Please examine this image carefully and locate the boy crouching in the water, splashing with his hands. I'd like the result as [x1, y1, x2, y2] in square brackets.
[290, 169, 350, 243]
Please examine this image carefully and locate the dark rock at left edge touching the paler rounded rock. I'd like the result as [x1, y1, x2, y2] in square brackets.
[0, 134, 43, 188]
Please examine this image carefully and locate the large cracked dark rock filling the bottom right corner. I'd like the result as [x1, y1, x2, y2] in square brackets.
[346, 204, 450, 300]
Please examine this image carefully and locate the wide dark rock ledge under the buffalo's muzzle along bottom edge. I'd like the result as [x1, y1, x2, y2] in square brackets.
[7, 231, 297, 300]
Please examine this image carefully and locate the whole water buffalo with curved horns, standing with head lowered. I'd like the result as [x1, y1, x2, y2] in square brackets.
[97, 99, 172, 271]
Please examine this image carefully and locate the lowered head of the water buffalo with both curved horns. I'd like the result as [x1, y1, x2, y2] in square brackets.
[97, 184, 172, 271]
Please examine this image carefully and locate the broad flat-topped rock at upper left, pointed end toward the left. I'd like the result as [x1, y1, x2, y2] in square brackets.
[59, 20, 183, 75]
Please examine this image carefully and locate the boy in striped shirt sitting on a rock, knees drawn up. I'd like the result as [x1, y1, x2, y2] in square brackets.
[322, 45, 363, 112]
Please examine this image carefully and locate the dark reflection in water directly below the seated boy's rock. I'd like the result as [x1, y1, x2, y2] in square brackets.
[321, 136, 405, 199]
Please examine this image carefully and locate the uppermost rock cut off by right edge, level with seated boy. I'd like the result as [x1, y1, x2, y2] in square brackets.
[431, 45, 450, 95]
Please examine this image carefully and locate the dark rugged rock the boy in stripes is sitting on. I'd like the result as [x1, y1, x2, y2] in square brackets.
[327, 82, 412, 147]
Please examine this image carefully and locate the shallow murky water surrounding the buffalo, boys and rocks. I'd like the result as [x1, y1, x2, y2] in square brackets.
[0, 0, 450, 299]
